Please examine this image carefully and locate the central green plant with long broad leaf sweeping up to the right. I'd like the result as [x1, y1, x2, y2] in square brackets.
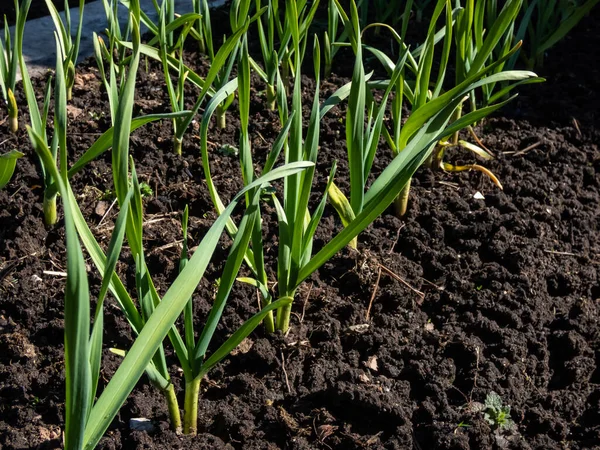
[200, 0, 529, 332]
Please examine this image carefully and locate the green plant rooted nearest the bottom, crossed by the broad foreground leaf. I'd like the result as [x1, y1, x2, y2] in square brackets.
[99, 2, 309, 434]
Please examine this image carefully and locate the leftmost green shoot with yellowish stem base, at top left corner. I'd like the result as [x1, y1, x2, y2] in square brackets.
[0, 0, 31, 133]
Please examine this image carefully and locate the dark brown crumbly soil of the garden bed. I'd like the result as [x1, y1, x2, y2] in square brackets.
[0, 5, 600, 449]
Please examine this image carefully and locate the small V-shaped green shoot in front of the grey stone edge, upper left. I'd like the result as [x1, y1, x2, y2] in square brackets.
[46, 0, 85, 100]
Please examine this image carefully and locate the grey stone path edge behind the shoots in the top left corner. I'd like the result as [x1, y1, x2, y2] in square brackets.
[14, 0, 225, 76]
